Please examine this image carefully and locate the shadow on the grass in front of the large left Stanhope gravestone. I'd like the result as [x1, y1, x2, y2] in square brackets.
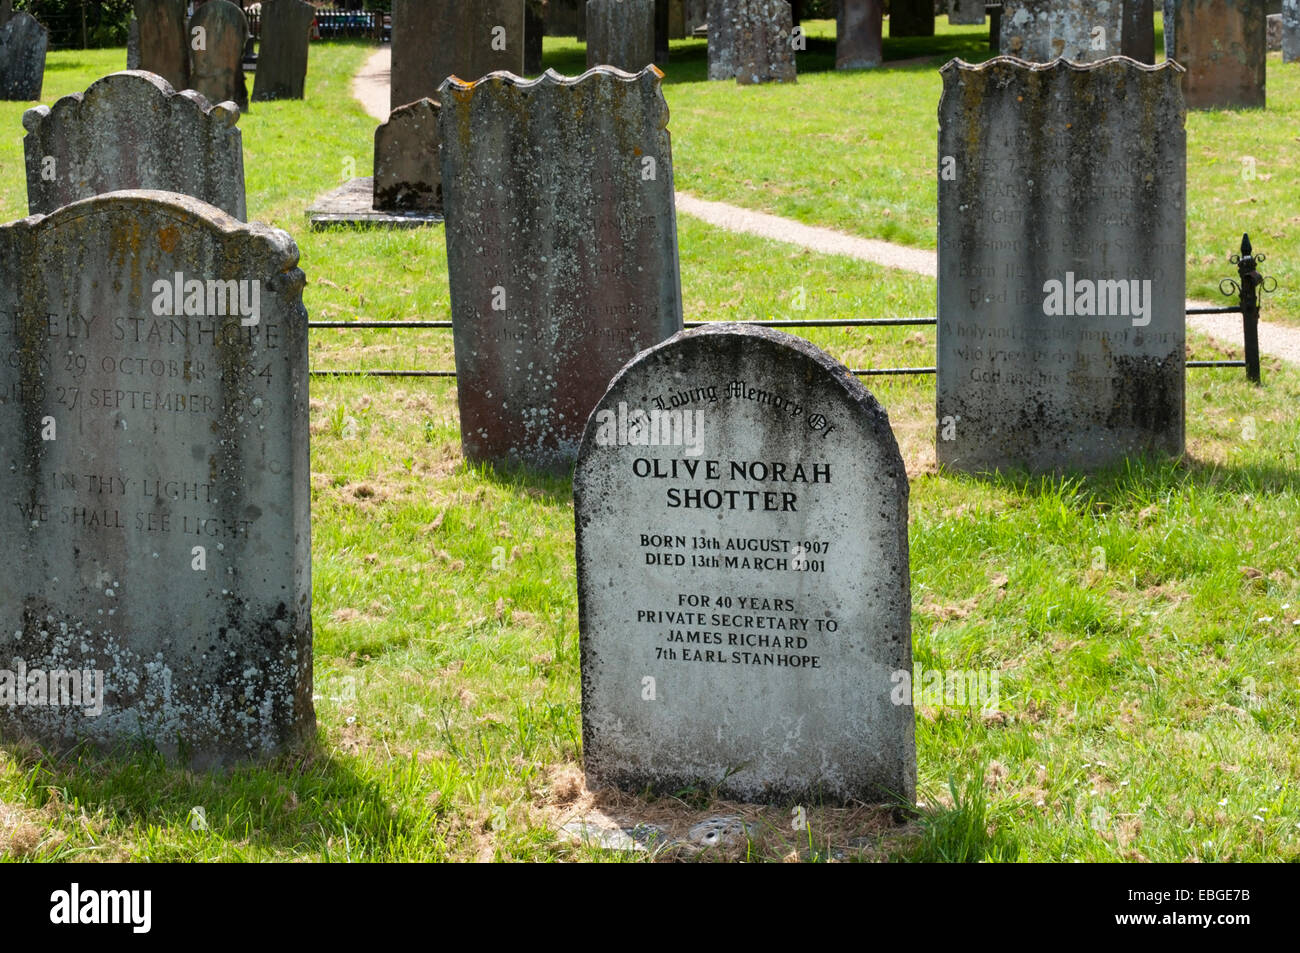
[0, 742, 439, 861]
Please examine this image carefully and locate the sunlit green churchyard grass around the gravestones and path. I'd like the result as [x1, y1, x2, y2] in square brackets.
[0, 36, 1300, 862]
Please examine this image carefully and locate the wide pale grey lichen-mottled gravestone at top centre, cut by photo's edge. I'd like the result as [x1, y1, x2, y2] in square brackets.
[709, 0, 796, 86]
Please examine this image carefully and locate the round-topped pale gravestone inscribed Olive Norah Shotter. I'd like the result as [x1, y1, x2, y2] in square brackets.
[573, 324, 917, 803]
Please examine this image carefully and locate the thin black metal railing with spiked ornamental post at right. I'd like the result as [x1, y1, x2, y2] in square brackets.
[307, 235, 1278, 384]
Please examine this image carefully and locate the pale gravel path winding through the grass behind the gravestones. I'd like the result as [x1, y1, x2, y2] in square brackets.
[352, 47, 1300, 364]
